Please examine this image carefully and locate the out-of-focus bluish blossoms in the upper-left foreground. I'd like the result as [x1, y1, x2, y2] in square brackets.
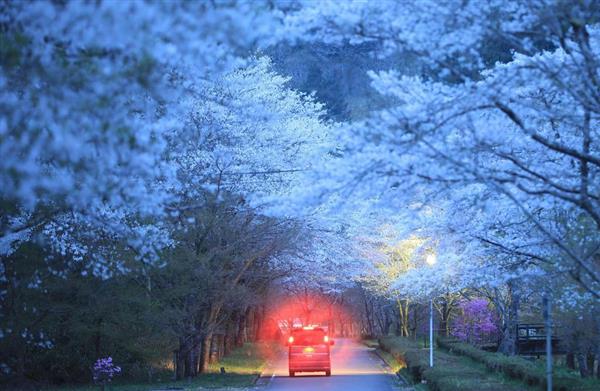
[0, 1, 286, 270]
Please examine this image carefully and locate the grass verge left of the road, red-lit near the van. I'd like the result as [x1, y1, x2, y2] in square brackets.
[46, 342, 280, 391]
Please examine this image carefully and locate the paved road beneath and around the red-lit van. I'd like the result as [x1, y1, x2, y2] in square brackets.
[267, 339, 397, 391]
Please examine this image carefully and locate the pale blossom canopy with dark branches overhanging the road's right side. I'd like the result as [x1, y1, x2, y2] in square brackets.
[286, 1, 599, 297]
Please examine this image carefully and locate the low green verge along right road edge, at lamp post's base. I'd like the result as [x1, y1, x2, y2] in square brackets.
[379, 337, 537, 391]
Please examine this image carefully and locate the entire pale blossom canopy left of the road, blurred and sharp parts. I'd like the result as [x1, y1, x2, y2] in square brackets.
[0, 1, 338, 278]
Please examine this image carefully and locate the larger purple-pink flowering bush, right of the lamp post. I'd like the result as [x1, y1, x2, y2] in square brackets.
[451, 298, 498, 344]
